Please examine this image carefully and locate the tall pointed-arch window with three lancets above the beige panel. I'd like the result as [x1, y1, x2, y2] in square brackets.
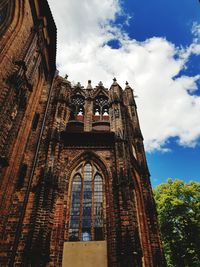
[69, 162, 104, 241]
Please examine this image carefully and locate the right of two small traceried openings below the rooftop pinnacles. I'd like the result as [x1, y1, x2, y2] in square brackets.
[93, 96, 109, 120]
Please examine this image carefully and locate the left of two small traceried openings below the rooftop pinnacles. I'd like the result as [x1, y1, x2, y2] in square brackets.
[70, 96, 85, 120]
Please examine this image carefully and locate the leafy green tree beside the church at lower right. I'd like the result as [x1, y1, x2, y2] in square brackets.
[154, 179, 200, 267]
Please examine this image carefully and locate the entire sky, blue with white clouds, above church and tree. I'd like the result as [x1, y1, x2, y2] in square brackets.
[49, 0, 200, 186]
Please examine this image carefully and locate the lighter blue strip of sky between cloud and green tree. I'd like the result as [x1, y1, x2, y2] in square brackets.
[147, 140, 200, 187]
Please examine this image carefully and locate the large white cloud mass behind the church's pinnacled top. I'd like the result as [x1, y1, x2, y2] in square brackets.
[49, 0, 200, 151]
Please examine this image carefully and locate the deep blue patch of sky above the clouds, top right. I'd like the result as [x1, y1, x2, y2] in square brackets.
[119, 0, 200, 45]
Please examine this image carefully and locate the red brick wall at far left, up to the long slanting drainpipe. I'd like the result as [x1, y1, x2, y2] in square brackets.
[0, 0, 56, 266]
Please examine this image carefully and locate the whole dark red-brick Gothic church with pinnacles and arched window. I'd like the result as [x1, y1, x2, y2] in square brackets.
[0, 0, 165, 267]
